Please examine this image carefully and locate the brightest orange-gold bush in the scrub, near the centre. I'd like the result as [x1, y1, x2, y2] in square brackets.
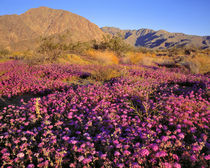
[86, 49, 119, 65]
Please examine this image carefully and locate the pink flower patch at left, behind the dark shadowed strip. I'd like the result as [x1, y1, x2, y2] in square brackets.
[0, 61, 83, 98]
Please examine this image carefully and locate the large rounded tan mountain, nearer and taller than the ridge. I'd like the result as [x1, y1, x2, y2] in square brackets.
[0, 7, 104, 49]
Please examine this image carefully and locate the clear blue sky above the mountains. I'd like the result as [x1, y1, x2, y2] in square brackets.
[0, 0, 210, 36]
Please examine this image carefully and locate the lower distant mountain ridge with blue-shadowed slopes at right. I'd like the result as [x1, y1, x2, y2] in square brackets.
[101, 27, 210, 49]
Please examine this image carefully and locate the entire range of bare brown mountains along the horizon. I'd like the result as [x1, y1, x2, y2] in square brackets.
[0, 7, 210, 50]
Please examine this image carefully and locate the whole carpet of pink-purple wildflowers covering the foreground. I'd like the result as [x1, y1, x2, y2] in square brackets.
[0, 61, 210, 168]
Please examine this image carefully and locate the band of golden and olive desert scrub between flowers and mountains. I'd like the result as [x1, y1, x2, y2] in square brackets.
[0, 37, 210, 74]
